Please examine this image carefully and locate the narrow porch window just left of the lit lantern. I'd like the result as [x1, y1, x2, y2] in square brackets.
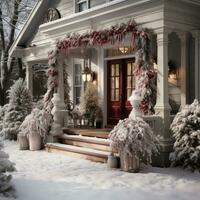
[74, 63, 82, 105]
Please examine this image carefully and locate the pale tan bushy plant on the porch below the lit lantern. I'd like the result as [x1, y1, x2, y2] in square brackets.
[80, 82, 99, 121]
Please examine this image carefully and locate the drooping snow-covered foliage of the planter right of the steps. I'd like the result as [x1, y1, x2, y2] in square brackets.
[109, 117, 158, 163]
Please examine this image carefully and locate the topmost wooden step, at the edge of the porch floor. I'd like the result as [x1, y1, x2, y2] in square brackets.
[63, 128, 111, 139]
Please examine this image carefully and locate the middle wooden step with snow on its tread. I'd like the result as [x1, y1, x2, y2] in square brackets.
[58, 134, 111, 152]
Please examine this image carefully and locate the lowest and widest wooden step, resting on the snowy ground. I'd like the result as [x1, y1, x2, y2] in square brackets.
[45, 143, 110, 163]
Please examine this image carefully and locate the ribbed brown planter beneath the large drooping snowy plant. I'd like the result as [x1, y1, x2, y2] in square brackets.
[120, 152, 140, 173]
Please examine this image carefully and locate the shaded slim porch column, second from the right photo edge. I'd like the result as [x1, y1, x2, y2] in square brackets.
[178, 32, 188, 107]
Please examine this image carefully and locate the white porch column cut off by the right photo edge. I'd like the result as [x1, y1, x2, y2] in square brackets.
[192, 30, 200, 101]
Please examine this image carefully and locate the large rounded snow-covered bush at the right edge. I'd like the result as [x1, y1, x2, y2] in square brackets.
[170, 100, 200, 171]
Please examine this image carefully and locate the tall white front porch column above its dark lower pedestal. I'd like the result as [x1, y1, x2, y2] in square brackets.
[155, 28, 171, 138]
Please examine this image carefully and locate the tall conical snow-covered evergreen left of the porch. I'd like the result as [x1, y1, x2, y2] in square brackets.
[1, 79, 32, 140]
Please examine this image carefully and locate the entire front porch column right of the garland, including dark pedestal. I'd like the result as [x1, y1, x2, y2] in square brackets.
[152, 28, 173, 167]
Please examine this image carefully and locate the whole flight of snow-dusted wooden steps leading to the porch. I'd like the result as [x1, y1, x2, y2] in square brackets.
[45, 128, 114, 163]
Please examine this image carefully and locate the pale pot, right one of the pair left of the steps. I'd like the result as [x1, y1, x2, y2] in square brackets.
[29, 133, 42, 151]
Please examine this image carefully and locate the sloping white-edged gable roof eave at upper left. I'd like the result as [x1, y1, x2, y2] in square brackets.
[9, 0, 50, 57]
